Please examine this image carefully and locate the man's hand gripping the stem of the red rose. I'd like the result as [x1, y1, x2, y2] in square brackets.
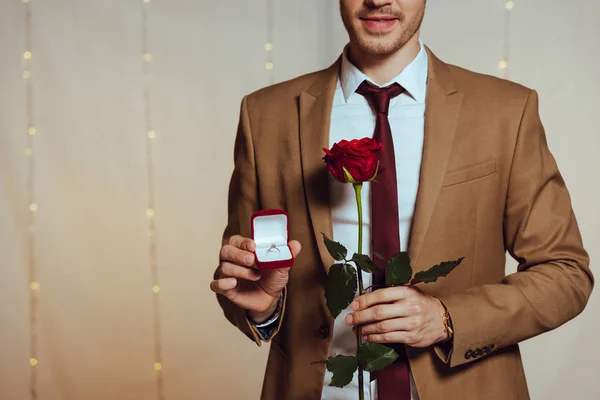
[346, 286, 448, 347]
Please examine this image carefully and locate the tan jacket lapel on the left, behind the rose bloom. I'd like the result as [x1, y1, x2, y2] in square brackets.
[299, 57, 341, 270]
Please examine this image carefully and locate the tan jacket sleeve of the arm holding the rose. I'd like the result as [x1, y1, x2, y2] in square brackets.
[434, 91, 594, 367]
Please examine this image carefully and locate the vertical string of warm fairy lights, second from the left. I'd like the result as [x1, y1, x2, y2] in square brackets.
[140, 0, 165, 400]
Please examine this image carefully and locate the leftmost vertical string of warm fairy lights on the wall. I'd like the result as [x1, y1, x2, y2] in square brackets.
[22, 0, 40, 400]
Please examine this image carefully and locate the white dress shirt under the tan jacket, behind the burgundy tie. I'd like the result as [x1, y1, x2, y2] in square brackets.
[322, 42, 427, 400]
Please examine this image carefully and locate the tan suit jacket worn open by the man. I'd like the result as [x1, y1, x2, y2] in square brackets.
[218, 49, 593, 400]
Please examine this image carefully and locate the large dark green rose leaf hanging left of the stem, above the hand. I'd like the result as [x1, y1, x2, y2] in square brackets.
[325, 264, 358, 318]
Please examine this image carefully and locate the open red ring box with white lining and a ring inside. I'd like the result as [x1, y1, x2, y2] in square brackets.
[251, 209, 294, 269]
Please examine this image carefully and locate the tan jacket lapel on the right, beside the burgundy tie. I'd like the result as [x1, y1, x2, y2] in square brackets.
[408, 48, 462, 265]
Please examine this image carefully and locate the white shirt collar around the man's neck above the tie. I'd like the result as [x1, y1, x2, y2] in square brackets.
[340, 40, 428, 103]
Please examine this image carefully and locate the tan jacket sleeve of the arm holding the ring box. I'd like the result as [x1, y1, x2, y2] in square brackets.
[215, 96, 287, 346]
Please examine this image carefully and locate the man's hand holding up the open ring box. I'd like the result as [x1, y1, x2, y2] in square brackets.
[210, 235, 301, 323]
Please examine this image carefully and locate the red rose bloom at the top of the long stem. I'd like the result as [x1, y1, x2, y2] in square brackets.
[323, 138, 383, 183]
